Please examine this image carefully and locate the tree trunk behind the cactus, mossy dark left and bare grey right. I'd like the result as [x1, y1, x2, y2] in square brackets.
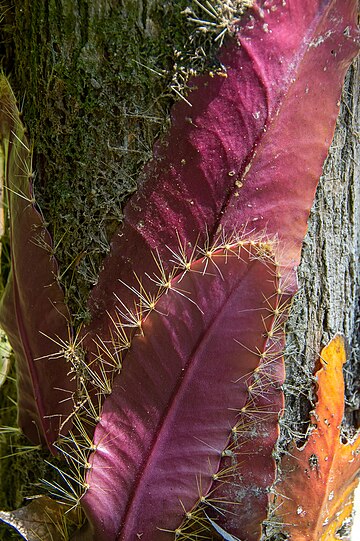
[0, 0, 360, 539]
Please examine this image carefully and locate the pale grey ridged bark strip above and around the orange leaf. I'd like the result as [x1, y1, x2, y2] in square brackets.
[282, 59, 360, 452]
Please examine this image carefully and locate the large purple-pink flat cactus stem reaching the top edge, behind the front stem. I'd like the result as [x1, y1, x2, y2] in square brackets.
[85, 0, 357, 351]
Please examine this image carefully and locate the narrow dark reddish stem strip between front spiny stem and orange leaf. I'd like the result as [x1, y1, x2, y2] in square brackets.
[210, 326, 289, 541]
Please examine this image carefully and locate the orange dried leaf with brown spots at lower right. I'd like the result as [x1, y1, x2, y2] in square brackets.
[276, 336, 360, 541]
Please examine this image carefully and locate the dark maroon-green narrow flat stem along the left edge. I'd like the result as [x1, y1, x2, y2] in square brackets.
[0, 76, 75, 448]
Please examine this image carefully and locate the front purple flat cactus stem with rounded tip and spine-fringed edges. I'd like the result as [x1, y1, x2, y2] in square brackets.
[82, 242, 279, 541]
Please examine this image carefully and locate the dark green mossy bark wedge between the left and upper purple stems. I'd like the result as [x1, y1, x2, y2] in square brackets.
[0, 0, 194, 320]
